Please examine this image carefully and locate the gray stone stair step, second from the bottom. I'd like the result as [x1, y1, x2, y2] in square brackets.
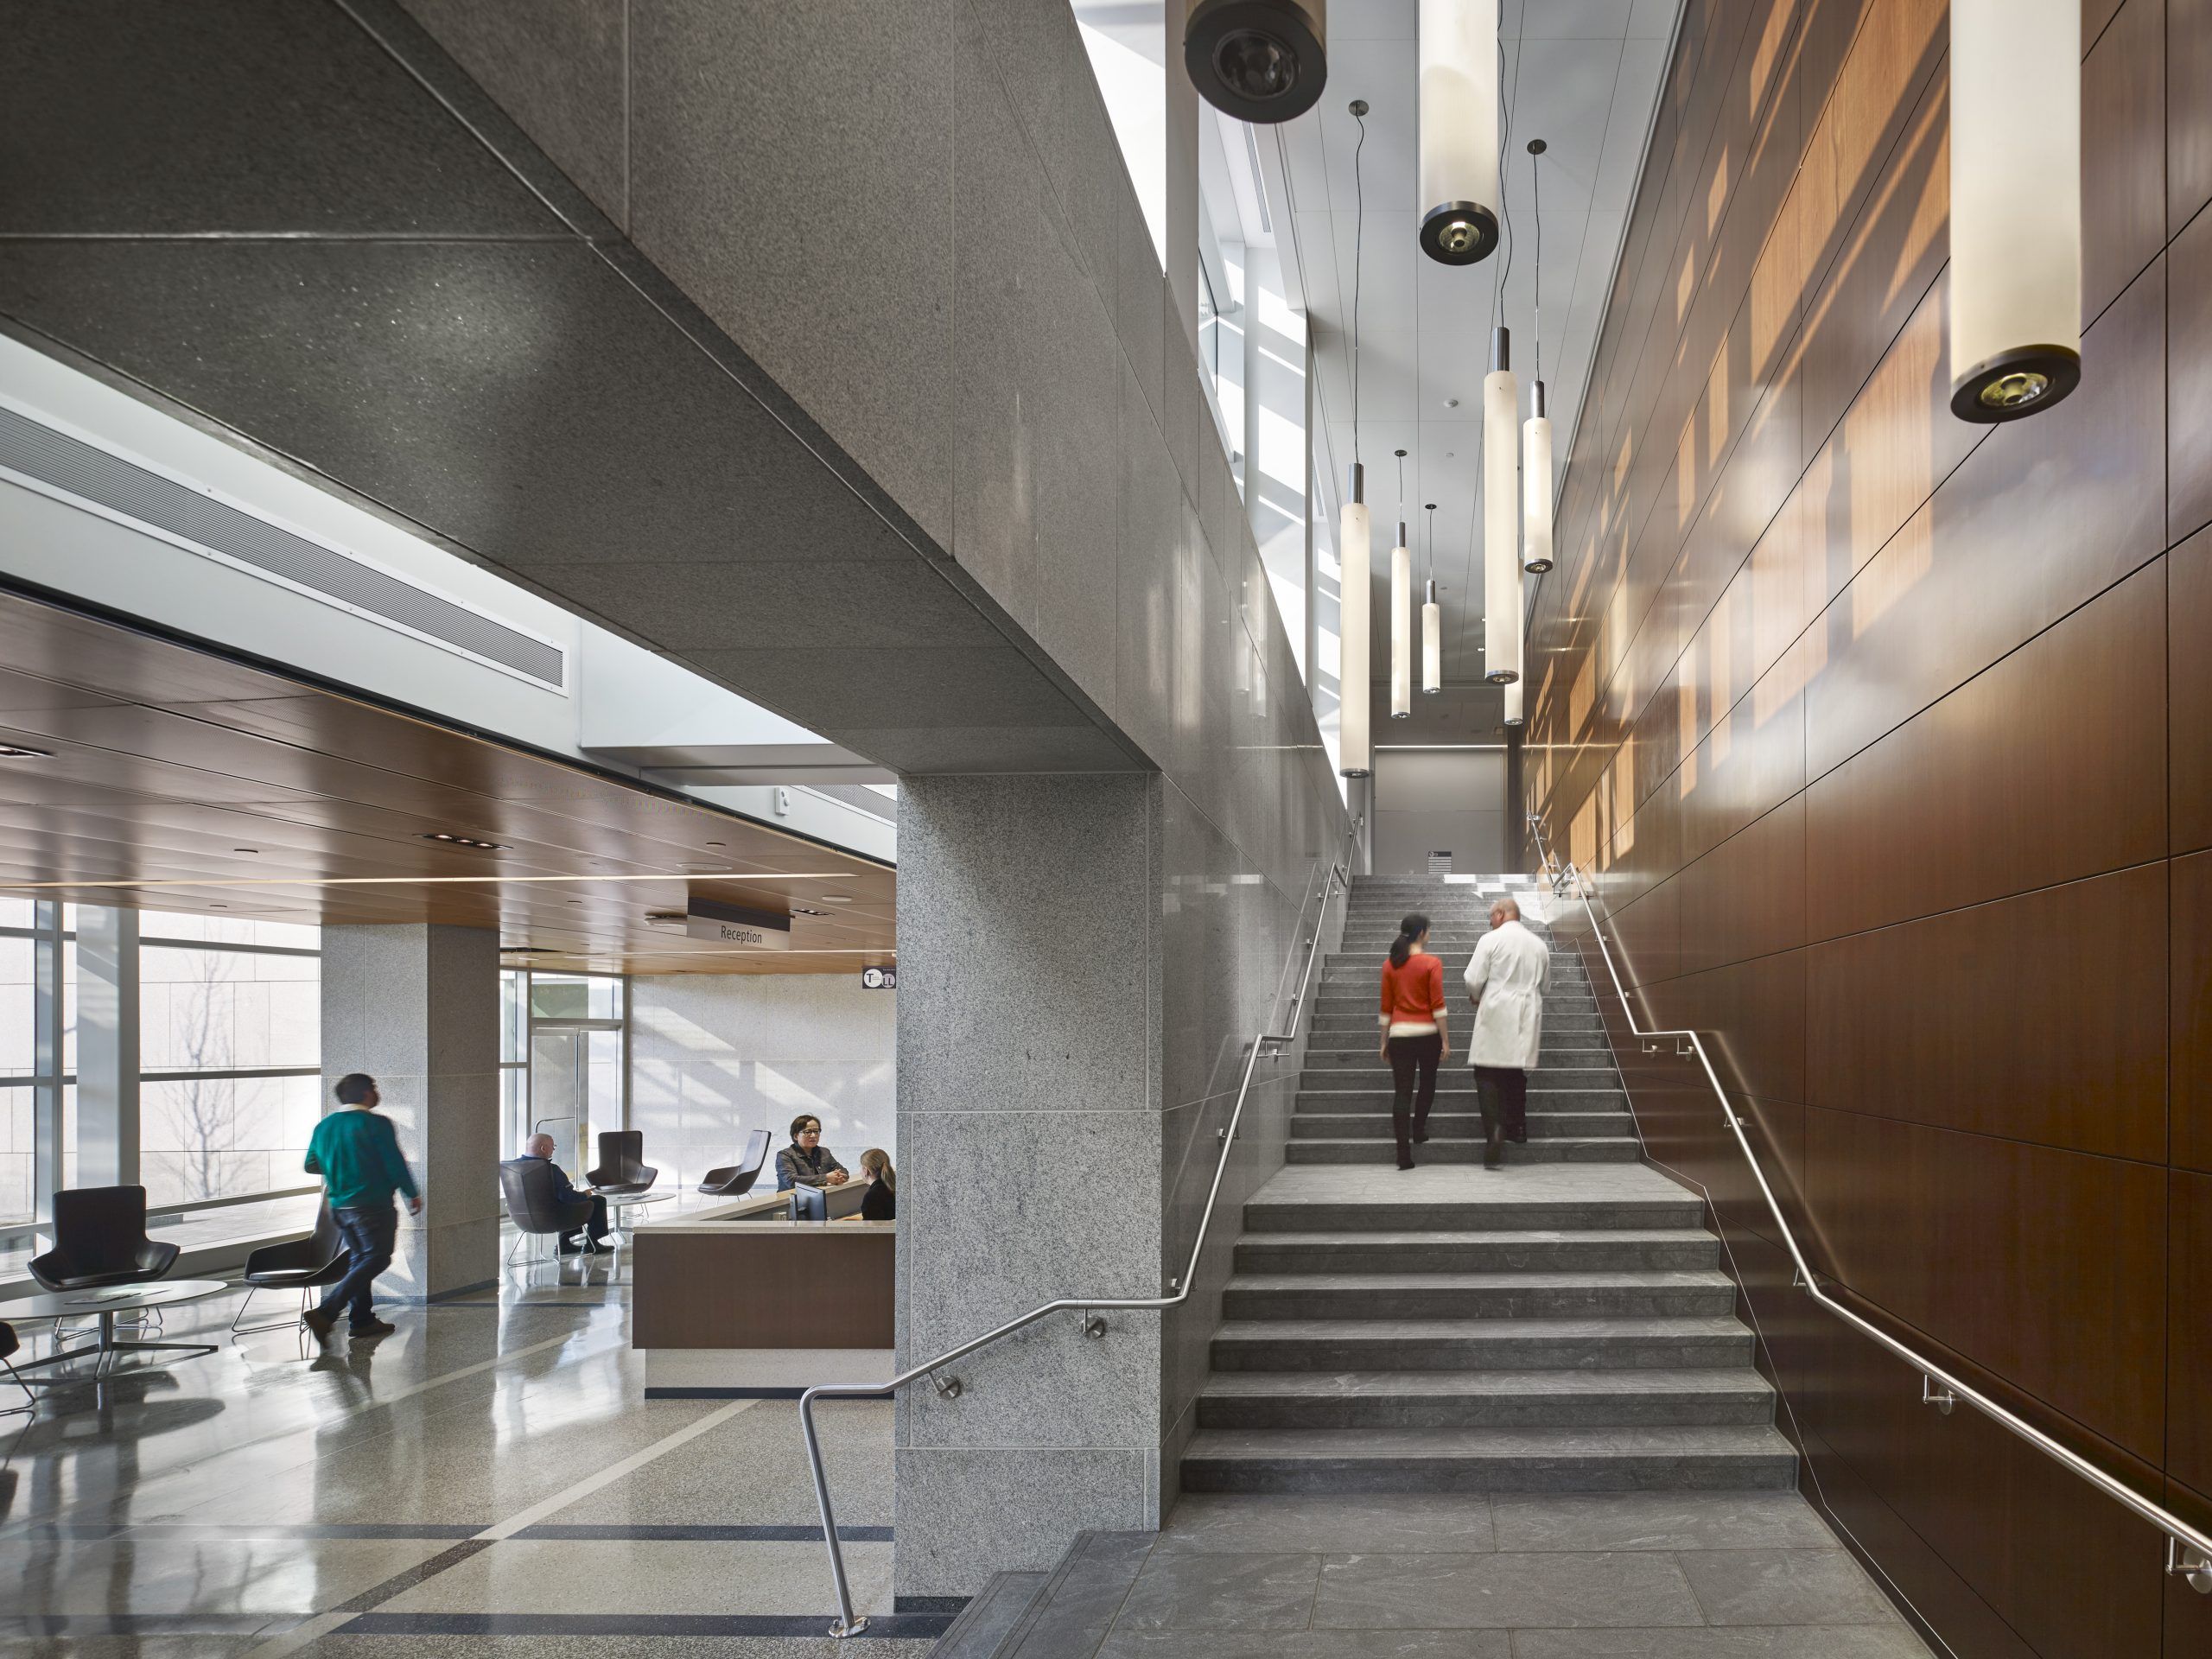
[1199, 1367, 1774, 1429]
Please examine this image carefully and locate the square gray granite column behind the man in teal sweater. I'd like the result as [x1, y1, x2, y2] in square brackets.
[323, 925, 506, 1299]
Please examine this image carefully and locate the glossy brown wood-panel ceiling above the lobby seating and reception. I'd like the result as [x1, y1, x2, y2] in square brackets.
[0, 595, 896, 973]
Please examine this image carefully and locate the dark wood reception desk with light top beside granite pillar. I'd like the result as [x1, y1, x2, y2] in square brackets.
[631, 1188, 898, 1398]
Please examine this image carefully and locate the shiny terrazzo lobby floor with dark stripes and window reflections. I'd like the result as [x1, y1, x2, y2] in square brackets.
[0, 1256, 915, 1659]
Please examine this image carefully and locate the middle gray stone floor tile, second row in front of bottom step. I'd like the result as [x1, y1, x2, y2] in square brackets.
[1314, 1553, 1706, 1630]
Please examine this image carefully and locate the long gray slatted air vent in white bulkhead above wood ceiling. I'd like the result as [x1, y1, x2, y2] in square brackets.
[0, 403, 566, 690]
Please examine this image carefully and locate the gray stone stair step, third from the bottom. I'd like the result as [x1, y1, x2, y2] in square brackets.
[1212, 1314, 1752, 1371]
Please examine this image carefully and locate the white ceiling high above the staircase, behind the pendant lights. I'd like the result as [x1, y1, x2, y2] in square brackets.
[1263, 0, 1679, 683]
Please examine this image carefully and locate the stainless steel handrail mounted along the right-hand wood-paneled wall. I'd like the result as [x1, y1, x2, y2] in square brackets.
[1529, 812, 2212, 1595]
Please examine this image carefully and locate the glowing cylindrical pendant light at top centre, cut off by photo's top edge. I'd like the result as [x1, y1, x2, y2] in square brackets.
[1418, 0, 1500, 265]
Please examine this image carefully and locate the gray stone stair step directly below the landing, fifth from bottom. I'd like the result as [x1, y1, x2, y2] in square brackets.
[1234, 1228, 1721, 1274]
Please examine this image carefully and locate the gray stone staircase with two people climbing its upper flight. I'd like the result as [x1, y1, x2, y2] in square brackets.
[1181, 878, 1796, 1493]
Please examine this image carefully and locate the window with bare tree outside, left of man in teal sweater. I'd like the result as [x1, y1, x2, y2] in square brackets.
[139, 912, 323, 1205]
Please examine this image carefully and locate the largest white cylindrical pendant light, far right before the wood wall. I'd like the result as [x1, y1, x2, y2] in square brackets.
[1951, 0, 2082, 423]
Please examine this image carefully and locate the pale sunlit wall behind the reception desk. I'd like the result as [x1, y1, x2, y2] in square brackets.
[631, 971, 898, 1188]
